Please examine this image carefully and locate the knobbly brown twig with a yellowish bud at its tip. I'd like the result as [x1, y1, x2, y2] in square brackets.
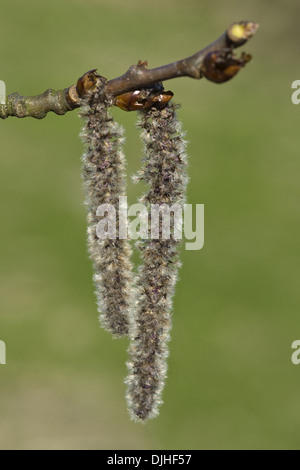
[0, 21, 258, 119]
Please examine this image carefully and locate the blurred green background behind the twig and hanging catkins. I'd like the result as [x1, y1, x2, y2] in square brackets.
[0, 0, 300, 449]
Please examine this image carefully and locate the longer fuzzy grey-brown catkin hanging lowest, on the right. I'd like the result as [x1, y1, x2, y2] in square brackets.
[126, 104, 188, 422]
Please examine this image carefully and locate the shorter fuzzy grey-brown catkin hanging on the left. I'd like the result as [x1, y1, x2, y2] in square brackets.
[80, 79, 132, 337]
